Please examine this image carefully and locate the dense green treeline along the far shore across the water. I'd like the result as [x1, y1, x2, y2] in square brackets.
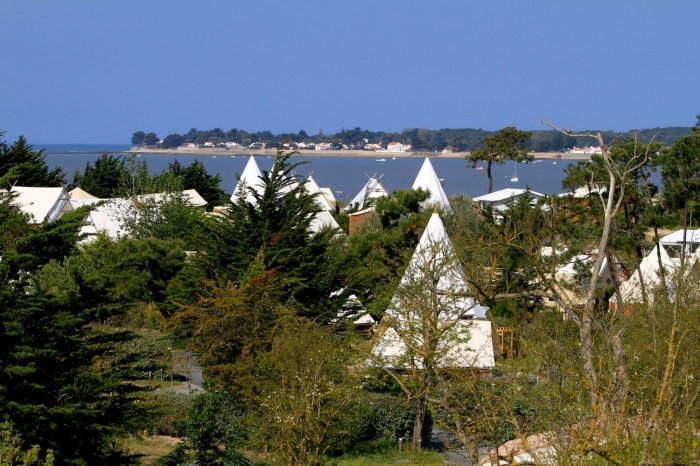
[131, 127, 691, 152]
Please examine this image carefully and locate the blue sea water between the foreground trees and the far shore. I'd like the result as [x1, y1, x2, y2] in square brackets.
[35, 144, 658, 200]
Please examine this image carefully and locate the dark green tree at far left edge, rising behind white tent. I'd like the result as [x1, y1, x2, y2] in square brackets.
[0, 131, 65, 189]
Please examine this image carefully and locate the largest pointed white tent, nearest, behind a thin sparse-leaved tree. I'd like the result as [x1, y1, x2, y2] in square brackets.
[372, 213, 494, 368]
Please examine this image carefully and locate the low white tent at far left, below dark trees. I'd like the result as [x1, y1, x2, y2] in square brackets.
[10, 186, 73, 224]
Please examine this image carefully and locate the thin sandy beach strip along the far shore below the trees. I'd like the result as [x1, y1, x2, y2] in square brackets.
[122, 148, 590, 160]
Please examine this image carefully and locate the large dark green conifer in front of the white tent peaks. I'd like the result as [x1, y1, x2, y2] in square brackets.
[200, 149, 342, 314]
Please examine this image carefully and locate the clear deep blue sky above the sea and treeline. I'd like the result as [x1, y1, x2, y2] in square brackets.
[0, 0, 700, 143]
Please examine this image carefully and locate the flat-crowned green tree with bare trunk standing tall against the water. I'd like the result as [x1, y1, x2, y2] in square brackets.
[465, 126, 534, 193]
